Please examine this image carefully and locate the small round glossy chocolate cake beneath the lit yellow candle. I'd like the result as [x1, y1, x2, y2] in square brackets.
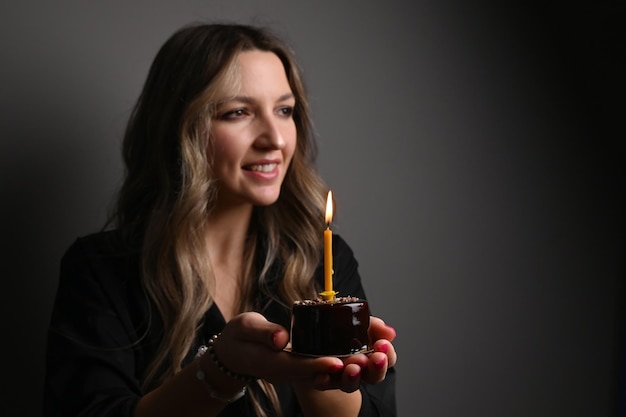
[291, 297, 370, 356]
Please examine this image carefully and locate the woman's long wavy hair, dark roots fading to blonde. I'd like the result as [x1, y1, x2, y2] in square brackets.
[114, 24, 326, 414]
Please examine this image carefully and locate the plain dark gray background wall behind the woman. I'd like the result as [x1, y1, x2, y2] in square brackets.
[0, 0, 625, 417]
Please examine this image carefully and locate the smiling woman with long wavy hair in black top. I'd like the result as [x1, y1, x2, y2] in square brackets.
[44, 24, 396, 417]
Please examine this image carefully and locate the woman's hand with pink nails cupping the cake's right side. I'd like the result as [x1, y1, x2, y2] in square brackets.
[315, 317, 398, 392]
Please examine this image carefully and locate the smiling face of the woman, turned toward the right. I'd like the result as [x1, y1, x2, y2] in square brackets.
[211, 50, 296, 210]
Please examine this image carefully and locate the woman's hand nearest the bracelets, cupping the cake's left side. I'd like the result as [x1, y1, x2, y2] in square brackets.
[215, 313, 344, 383]
